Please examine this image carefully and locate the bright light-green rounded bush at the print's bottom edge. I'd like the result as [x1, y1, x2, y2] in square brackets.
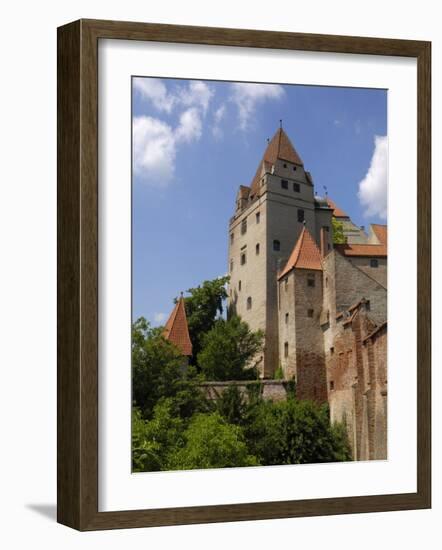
[169, 412, 259, 470]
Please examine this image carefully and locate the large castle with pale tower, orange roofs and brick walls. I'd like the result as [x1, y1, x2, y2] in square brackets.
[228, 127, 387, 460]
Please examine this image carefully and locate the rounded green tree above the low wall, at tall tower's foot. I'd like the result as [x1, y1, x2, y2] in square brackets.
[198, 316, 263, 380]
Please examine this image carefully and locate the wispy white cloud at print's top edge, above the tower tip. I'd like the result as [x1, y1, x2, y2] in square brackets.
[231, 83, 284, 130]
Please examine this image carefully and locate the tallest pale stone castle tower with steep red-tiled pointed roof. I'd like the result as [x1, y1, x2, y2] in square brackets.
[228, 127, 332, 378]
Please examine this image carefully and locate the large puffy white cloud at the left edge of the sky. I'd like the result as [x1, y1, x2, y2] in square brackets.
[133, 108, 202, 187]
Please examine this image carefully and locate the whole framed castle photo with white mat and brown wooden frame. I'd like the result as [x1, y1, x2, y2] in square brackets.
[58, 20, 431, 530]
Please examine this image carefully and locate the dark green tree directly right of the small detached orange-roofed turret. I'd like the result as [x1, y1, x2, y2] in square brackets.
[184, 276, 229, 363]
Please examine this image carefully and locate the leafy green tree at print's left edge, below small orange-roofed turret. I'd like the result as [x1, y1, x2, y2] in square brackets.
[132, 318, 208, 420]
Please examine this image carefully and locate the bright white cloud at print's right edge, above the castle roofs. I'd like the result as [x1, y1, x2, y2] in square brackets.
[358, 136, 388, 220]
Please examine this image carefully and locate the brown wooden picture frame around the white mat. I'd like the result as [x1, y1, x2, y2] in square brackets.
[57, 20, 431, 531]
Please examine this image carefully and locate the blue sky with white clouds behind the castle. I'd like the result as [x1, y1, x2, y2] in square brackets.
[132, 78, 388, 325]
